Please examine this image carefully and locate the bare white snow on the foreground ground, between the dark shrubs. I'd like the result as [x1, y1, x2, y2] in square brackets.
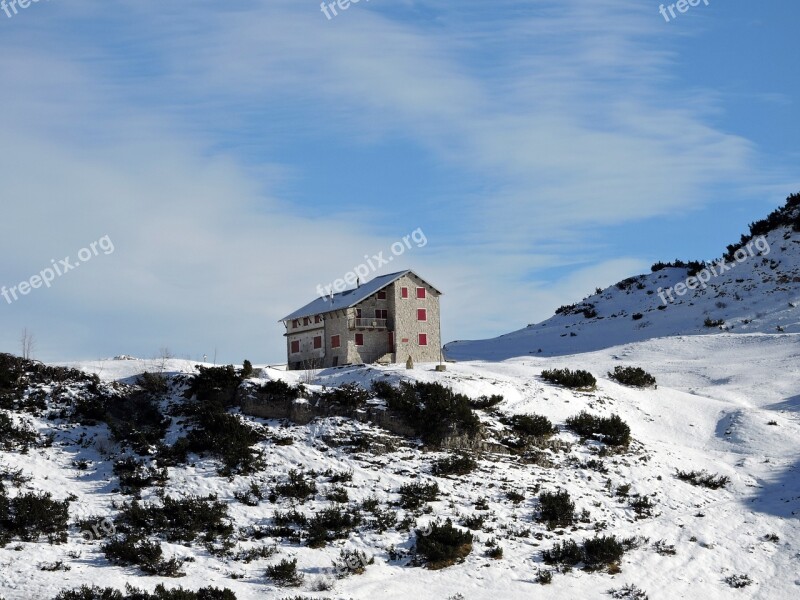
[0, 334, 800, 600]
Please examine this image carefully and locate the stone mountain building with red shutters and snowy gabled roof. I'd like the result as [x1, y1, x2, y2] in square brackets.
[281, 271, 442, 369]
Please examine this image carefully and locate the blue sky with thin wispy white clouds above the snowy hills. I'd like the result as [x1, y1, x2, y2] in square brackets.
[0, 0, 800, 362]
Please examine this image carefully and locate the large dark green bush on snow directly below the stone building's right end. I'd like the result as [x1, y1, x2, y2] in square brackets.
[372, 381, 480, 445]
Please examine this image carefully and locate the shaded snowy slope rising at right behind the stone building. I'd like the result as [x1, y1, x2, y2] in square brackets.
[445, 195, 800, 360]
